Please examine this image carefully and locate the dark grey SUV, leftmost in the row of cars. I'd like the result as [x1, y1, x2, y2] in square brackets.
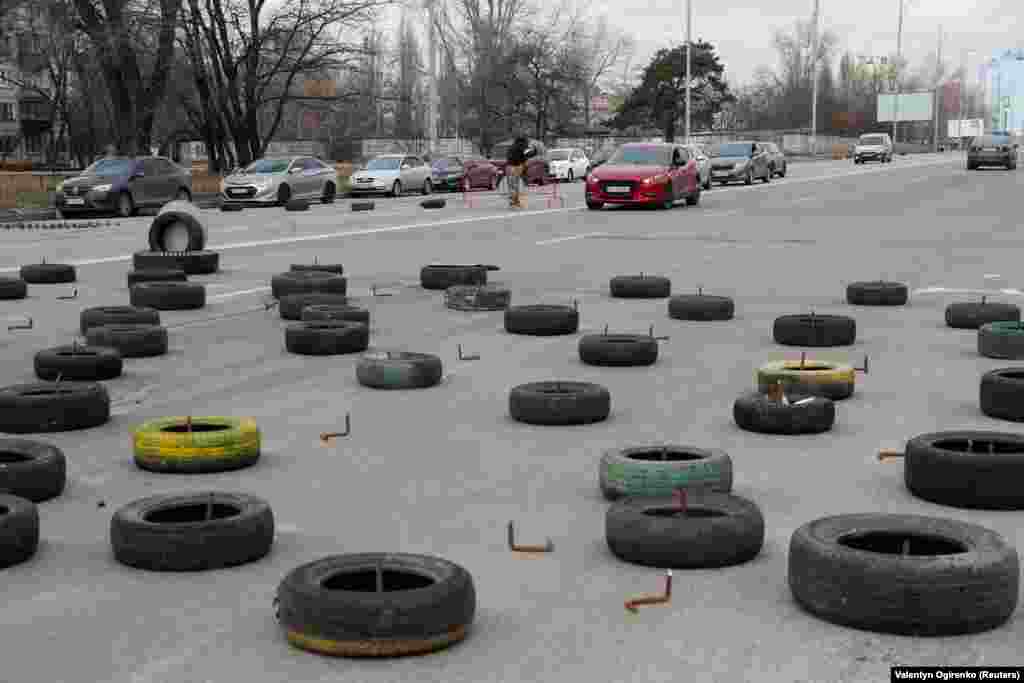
[56, 157, 191, 218]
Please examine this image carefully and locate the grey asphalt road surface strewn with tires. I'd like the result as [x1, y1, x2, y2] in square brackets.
[0, 155, 1024, 683]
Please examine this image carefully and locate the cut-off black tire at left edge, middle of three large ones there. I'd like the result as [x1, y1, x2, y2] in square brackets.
[0, 438, 68, 503]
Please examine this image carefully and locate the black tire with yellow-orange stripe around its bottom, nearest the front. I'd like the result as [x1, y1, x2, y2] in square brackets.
[278, 553, 476, 657]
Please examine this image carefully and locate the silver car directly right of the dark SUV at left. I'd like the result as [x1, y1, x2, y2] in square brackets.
[220, 157, 338, 206]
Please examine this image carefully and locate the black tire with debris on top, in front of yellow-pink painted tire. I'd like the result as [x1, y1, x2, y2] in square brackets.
[732, 392, 836, 434]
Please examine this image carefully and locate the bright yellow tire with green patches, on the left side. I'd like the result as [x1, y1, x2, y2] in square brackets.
[132, 417, 260, 473]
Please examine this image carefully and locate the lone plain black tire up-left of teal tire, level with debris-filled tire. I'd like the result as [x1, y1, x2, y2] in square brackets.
[509, 381, 611, 425]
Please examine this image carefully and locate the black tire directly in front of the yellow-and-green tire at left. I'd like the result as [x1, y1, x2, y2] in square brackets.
[111, 492, 273, 571]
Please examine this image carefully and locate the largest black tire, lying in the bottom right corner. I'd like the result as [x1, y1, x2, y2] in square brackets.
[788, 513, 1020, 636]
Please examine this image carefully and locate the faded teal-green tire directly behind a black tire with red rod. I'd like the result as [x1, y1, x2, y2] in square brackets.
[598, 443, 732, 501]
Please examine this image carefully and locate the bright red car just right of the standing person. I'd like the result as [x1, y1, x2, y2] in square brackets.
[587, 142, 700, 210]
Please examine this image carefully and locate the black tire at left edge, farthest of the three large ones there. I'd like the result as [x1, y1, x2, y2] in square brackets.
[0, 382, 111, 434]
